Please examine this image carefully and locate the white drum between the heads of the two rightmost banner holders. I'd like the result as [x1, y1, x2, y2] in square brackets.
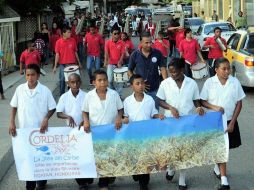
[191, 62, 208, 79]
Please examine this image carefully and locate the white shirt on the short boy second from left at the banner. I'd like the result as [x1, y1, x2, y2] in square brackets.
[56, 89, 86, 126]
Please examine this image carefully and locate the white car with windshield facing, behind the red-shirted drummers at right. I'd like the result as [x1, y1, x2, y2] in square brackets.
[194, 22, 236, 51]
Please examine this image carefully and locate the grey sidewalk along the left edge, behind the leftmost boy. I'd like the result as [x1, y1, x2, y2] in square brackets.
[0, 65, 58, 181]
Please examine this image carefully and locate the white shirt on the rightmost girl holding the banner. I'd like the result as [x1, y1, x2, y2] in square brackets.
[200, 75, 245, 121]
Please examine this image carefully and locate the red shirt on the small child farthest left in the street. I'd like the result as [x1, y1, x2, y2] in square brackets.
[20, 50, 41, 65]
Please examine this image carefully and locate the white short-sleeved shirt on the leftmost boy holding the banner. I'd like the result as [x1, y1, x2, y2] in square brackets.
[10, 81, 56, 128]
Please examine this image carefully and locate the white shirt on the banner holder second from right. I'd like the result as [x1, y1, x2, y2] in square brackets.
[157, 76, 199, 117]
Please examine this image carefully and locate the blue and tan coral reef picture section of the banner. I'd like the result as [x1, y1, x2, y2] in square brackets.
[92, 112, 228, 177]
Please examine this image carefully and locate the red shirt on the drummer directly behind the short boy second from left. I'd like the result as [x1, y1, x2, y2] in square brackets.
[55, 38, 78, 64]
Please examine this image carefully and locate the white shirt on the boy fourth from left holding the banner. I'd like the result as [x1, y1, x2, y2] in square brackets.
[123, 93, 158, 122]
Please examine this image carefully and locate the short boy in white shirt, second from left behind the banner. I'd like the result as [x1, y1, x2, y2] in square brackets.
[56, 73, 93, 190]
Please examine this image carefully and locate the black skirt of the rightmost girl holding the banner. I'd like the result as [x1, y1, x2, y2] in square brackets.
[227, 121, 242, 149]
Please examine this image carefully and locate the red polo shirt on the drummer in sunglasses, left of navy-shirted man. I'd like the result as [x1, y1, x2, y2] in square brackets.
[105, 39, 125, 65]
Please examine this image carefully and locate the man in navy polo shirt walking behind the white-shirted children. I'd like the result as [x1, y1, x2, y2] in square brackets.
[128, 33, 167, 110]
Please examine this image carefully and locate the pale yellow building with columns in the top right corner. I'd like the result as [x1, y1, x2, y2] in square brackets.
[193, 0, 254, 25]
